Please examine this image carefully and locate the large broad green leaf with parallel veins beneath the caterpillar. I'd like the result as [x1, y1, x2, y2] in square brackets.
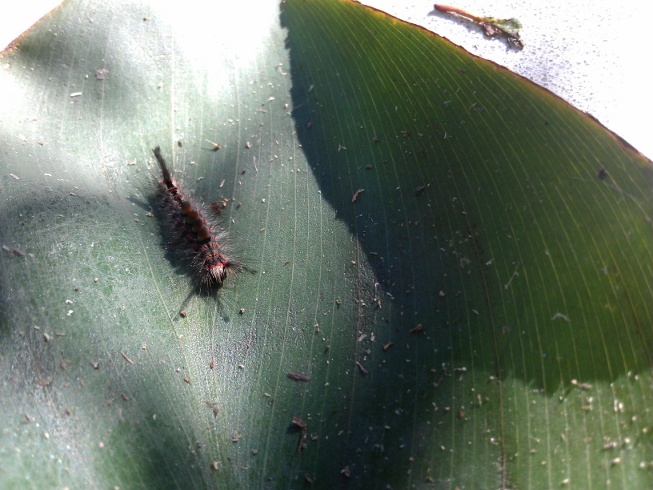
[0, 0, 653, 489]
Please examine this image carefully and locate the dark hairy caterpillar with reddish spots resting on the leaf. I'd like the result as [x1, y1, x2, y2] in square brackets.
[152, 146, 241, 288]
